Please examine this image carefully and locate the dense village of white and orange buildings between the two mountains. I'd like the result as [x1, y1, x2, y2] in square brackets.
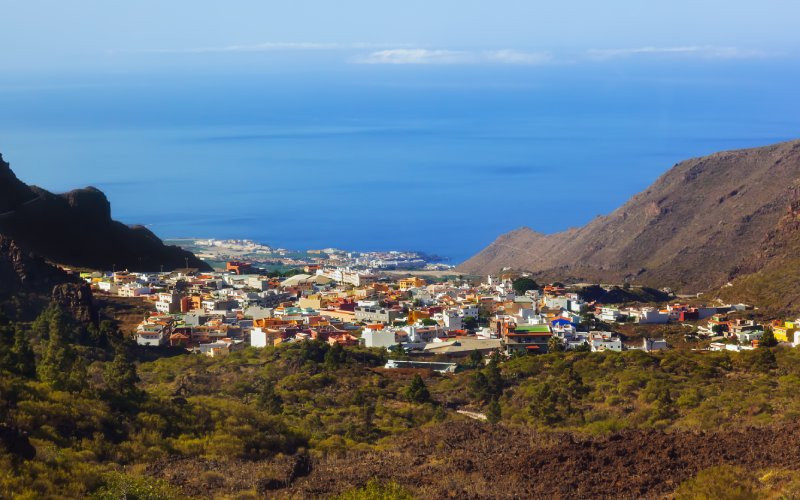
[82, 262, 800, 371]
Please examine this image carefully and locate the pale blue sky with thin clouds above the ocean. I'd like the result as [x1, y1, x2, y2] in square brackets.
[0, 0, 800, 76]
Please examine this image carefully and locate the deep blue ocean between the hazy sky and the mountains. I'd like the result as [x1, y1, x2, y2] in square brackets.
[0, 61, 800, 263]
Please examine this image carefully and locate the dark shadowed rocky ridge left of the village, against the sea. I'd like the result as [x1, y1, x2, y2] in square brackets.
[0, 156, 211, 271]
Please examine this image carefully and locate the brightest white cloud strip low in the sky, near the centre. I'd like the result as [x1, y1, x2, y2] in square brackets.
[352, 48, 551, 64]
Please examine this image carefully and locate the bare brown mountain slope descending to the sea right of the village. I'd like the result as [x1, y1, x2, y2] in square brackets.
[459, 141, 800, 291]
